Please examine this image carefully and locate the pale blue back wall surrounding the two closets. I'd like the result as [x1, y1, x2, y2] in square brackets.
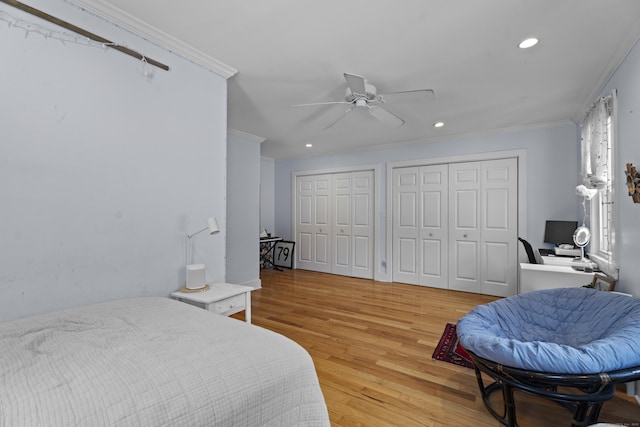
[275, 123, 579, 280]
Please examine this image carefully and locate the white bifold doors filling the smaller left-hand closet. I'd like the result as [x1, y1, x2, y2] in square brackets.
[295, 171, 374, 279]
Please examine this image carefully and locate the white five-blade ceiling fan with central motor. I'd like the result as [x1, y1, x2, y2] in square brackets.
[293, 73, 435, 130]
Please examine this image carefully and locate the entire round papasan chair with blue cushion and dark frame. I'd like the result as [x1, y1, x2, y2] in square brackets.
[457, 288, 640, 427]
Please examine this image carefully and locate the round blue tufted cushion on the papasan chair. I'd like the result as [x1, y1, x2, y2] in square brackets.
[457, 288, 640, 374]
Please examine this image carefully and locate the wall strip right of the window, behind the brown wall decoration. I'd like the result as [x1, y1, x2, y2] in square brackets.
[594, 37, 640, 297]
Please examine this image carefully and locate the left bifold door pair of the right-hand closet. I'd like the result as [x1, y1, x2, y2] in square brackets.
[392, 165, 449, 289]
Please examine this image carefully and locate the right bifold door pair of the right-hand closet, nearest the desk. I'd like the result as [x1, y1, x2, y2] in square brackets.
[449, 159, 518, 296]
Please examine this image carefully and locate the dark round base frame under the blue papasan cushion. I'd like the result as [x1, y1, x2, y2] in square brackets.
[466, 350, 640, 427]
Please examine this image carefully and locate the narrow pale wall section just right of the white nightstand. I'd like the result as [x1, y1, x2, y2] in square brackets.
[227, 134, 260, 288]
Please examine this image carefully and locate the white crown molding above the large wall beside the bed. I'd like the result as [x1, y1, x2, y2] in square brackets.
[65, 0, 238, 79]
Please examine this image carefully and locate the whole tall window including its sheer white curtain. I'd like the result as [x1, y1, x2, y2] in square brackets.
[582, 92, 618, 279]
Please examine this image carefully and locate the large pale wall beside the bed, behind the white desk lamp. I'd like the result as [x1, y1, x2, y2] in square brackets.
[0, 0, 227, 320]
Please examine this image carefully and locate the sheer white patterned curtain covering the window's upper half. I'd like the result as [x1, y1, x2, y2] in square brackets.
[581, 91, 615, 189]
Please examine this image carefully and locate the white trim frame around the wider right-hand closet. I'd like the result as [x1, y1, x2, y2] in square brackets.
[388, 149, 527, 290]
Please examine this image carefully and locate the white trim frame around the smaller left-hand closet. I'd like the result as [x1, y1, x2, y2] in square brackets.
[291, 165, 386, 280]
